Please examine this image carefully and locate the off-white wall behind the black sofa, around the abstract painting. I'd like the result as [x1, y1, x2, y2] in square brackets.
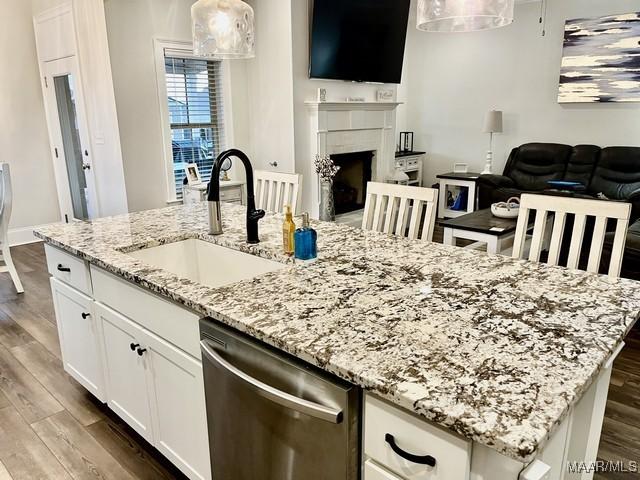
[398, 0, 640, 188]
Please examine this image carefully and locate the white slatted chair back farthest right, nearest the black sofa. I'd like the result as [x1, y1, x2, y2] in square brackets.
[513, 193, 631, 277]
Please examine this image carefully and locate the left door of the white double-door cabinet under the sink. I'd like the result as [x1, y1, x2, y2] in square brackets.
[95, 303, 153, 443]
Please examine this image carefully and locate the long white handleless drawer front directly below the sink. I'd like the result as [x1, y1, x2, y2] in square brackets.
[91, 266, 201, 360]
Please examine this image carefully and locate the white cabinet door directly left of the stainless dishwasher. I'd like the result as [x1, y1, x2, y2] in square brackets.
[145, 333, 211, 480]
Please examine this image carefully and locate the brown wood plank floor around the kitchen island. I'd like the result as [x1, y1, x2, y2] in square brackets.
[0, 242, 640, 480]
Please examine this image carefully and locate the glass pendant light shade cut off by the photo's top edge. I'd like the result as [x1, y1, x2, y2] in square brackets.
[417, 0, 514, 32]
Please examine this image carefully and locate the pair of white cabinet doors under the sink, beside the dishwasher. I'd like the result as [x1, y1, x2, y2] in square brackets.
[95, 303, 210, 479]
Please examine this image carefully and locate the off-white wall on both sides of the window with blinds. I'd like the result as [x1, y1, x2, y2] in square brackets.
[104, 0, 249, 211]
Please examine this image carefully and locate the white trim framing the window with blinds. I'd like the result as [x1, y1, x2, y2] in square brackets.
[153, 38, 233, 204]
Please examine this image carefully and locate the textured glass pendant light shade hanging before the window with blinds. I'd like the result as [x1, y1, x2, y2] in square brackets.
[191, 0, 255, 60]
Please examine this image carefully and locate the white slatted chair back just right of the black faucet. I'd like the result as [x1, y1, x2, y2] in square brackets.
[253, 170, 302, 215]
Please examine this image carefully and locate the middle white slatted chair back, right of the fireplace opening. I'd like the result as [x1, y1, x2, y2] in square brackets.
[362, 182, 438, 242]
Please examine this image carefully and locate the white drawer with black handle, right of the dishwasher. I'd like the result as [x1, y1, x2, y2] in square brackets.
[364, 395, 471, 480]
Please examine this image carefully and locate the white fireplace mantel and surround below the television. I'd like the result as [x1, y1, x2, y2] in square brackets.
[303, 102, 401, 218]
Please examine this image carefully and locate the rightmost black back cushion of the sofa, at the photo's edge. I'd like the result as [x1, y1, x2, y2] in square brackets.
[589, 147, 640, 200]
